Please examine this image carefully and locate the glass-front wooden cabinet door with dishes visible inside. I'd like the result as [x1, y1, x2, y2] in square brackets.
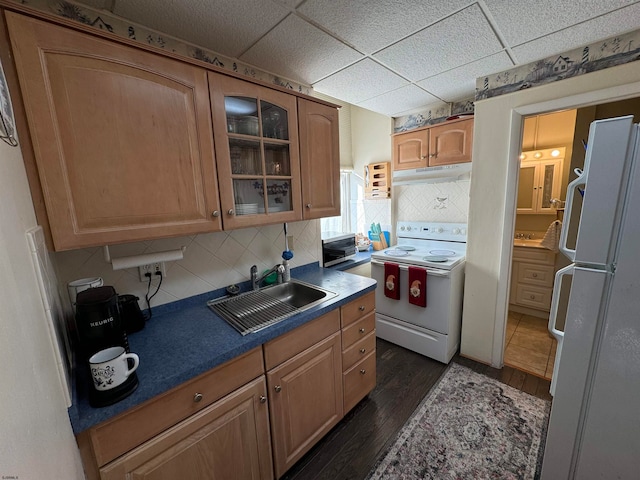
[209, 73, 302, 228]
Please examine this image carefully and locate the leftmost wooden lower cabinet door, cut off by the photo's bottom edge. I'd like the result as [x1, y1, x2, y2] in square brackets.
[100, 376, 273, 480]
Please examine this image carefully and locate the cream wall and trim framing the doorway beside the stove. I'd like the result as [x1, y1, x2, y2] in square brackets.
[461, 62, 640, 366]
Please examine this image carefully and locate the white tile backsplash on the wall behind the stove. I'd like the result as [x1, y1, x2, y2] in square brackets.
[394, 180, 471, 223]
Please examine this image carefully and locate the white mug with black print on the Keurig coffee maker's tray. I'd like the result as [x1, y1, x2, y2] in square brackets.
[89, 347, 140, 391]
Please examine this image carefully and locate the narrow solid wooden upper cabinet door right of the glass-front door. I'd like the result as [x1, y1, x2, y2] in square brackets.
[298, 98, 340, 220]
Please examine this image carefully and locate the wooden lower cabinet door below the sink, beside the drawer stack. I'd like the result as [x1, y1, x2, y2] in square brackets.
[267, 331, 343, 478]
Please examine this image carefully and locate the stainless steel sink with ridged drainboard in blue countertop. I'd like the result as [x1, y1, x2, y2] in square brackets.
[207, 280, 338, 335]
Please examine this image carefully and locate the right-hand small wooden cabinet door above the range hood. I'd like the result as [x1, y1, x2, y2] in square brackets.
[429, 119, 473, 167]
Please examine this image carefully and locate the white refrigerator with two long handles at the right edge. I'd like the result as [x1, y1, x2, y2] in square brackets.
[542, 116, 640, 480]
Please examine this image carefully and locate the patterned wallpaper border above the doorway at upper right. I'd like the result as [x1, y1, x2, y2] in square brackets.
[475, 30, 640, 101]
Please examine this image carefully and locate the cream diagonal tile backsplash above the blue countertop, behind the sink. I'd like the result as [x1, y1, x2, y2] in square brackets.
[53, 220, 322, 309]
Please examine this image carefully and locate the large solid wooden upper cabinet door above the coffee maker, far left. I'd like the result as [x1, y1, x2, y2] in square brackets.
[6, 12, 222, 250]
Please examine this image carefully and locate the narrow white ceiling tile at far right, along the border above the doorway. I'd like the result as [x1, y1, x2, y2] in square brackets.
[513, 3, 640, 64]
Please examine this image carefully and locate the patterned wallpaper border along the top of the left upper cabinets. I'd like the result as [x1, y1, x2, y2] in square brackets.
[8, 0, 313, 95]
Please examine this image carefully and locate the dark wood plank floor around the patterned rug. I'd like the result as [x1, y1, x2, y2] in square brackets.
[282, 339, 551, 480]
